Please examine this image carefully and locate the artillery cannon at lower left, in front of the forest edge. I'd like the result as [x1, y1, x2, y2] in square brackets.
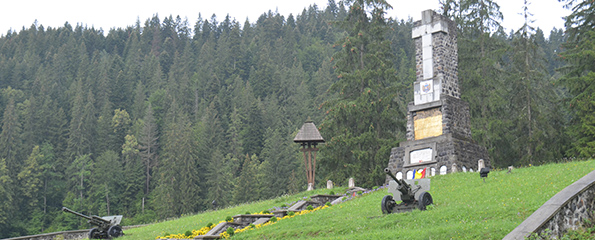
[62, 207, 124, 239]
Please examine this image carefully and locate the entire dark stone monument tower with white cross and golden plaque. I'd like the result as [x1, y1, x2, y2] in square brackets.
[388, 10, 490, 179]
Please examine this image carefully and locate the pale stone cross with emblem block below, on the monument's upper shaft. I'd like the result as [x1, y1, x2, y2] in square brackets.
[412, 10, 448, 105]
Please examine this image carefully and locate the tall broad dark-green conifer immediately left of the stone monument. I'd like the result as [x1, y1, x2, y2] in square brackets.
[319, 0, 404, 186]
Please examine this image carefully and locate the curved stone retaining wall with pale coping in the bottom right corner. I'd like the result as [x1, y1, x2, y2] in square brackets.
[504, 171, 595, 239]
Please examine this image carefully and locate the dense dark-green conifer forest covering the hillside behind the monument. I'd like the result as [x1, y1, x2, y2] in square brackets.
[0, 0, 595, 238]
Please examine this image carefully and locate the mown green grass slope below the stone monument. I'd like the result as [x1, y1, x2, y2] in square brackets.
[122, 160, 595, 240]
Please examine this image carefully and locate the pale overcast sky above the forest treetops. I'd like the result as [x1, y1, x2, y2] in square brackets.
[0, 0, 570, 36]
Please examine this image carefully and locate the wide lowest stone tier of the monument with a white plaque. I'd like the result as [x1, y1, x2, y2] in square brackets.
[386, 134, 491, 182]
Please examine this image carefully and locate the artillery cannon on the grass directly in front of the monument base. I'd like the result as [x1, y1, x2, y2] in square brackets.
[381, 168, 434, 214]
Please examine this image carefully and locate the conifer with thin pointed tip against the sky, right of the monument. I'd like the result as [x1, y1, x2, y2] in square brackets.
[508, 0, 564, 164]
